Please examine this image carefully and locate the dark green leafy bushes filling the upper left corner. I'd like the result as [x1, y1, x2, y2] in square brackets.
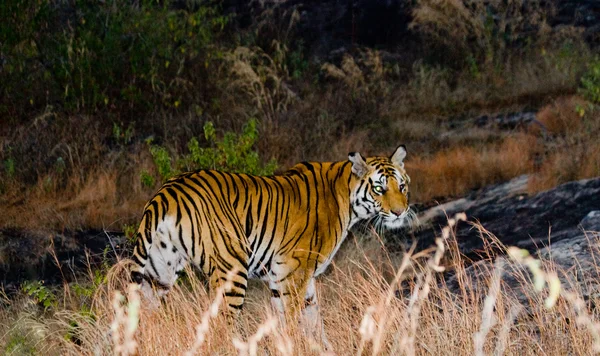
[0, 0, 228, 117]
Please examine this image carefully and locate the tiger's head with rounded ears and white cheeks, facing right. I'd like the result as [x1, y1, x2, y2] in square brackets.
[348, 145, 414, 229]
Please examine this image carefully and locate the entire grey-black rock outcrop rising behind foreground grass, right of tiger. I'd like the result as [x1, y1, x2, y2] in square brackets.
[398, 176, 600, 304]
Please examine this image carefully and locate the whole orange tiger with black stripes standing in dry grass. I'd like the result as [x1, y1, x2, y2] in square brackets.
[131, 145, 410, 340]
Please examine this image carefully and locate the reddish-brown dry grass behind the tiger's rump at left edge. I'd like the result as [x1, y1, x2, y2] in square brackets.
[2, 147, 155, 231]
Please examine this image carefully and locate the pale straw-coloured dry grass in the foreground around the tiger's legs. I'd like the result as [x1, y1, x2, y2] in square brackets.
[0, 220, 600, 355]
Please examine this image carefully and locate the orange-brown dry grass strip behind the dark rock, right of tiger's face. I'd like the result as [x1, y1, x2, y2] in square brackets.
[406, 96, 600, 202]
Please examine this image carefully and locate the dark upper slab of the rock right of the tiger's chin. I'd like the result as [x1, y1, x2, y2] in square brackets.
[414, 176, 600, 260]
